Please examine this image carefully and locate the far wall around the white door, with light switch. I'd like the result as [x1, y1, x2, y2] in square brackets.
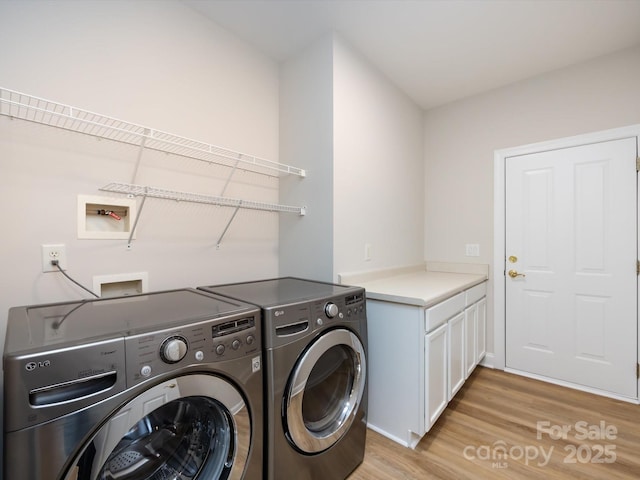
[424, 47, 640, 358]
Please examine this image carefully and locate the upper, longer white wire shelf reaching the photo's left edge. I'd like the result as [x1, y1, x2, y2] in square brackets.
[0, 87, 305, 177]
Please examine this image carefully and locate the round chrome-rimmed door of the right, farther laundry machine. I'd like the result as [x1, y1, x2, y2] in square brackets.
[283, 328, 367, 454]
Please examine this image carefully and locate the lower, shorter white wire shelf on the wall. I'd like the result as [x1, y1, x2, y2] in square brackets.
[100, 182, 306, 215]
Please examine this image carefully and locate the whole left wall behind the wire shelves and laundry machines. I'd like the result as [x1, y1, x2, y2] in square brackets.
[0, 1, 279, 464]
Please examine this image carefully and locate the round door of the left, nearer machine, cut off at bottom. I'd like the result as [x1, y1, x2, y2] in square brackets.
[62, 374, 251, 480]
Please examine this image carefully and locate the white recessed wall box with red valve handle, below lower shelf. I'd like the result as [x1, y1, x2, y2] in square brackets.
[78, 195, 137, 240]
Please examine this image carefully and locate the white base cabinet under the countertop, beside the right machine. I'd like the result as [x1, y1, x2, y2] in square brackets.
[367, 282, 486, 448]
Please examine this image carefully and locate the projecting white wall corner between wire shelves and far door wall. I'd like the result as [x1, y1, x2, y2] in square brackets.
[280, 34, 424, 281]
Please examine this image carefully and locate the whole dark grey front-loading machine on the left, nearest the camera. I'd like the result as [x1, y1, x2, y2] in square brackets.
[3, 289, 264, 480]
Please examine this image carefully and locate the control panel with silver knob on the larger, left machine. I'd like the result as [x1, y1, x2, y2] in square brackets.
[125, 309, 262, 387]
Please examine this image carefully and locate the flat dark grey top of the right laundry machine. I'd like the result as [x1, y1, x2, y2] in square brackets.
[199, 277, 362, 308]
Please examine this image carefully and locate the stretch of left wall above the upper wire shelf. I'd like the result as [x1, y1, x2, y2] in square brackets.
[0, 0, 278, 154]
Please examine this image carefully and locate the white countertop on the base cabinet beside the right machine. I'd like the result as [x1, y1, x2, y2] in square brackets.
[342, 262, 487, 307]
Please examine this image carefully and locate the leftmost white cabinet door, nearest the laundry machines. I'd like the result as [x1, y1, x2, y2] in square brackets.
[424, 324, 448, 431]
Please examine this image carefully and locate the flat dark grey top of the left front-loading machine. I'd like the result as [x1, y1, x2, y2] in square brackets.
[4, 289, 256, 356]
